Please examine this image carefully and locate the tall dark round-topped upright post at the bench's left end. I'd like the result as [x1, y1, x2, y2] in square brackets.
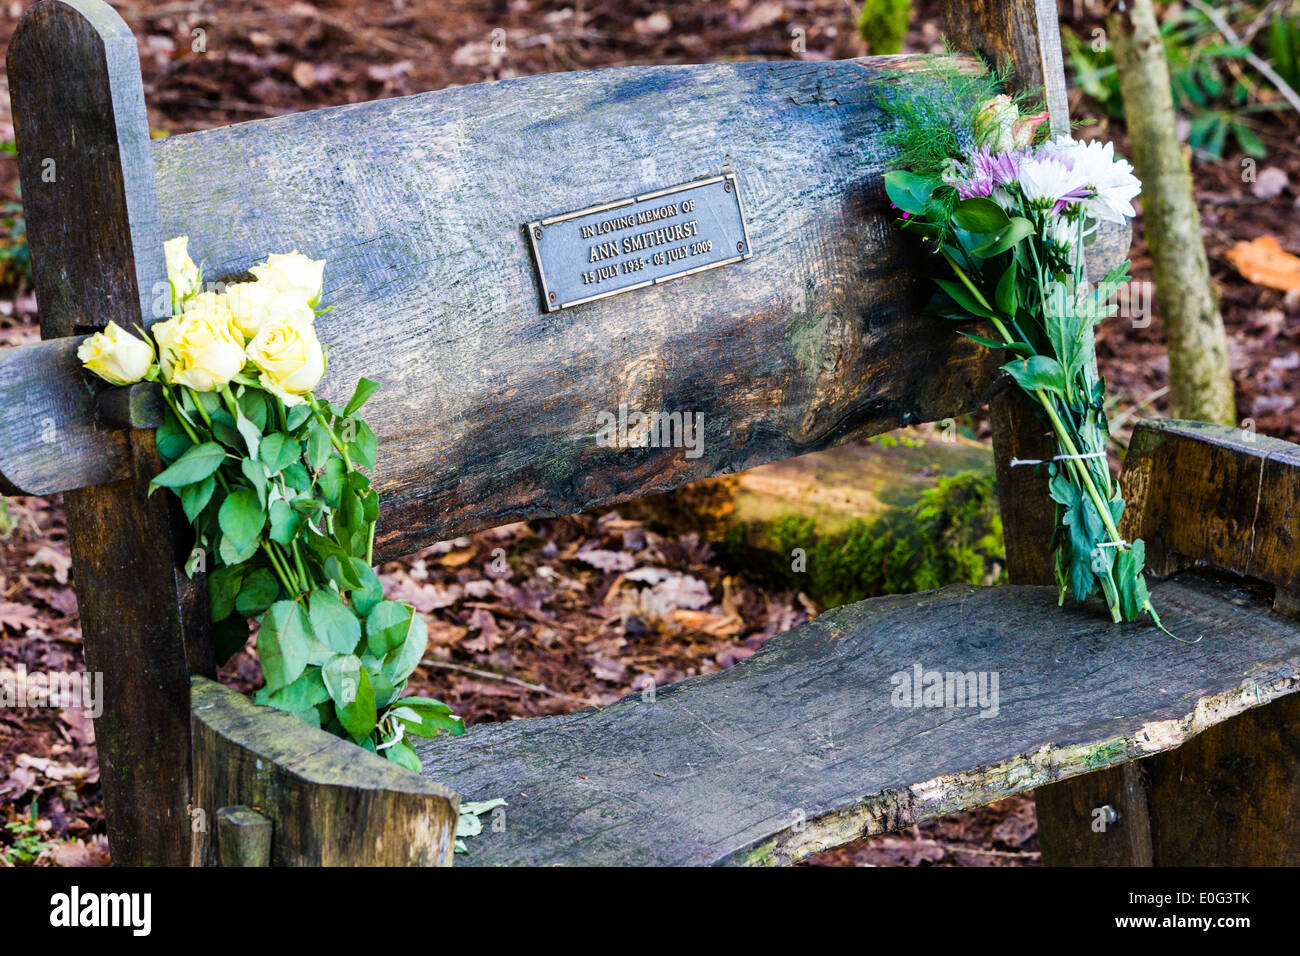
[8, 0, 209, 865]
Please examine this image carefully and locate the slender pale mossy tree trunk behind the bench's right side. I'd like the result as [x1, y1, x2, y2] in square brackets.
[1109, 0, 1236, 425]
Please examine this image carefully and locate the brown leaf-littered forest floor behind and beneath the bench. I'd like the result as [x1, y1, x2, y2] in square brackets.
[0, 0, 1300, 865]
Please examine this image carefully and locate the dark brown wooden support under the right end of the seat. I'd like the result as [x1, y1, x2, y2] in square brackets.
[1035, 695, 1300, 866]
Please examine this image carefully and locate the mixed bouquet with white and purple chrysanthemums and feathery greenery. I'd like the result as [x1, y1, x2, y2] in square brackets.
[881, 72, 1160, 624]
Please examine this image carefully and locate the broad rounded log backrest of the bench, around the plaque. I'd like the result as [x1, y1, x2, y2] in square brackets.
[153, 57, 996, 555]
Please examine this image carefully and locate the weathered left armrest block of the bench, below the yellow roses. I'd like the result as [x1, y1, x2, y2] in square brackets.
[191, 678, 459, 866]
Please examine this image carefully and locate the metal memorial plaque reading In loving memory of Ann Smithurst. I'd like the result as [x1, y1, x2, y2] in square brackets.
[524, 173, 753, 312]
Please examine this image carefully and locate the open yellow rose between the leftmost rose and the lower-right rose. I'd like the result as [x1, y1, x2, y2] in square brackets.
[151, 293, 244, 392]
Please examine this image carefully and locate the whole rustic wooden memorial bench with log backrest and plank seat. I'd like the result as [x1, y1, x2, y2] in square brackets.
[0, 0, 1300, 865]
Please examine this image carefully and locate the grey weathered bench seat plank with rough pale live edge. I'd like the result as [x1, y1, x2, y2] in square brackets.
[421, 572, 1300, 865]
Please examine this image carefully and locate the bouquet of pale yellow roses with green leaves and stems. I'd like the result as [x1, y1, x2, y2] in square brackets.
[77, 237, 464, 771]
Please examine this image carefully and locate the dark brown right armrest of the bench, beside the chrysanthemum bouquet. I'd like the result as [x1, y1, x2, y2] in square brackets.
[1121, 420, 1300, 607]
